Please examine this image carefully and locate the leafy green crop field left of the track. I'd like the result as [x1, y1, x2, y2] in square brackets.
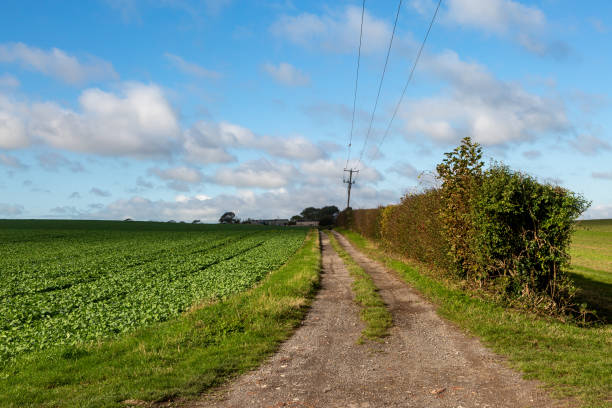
[0, 220, 307, 367]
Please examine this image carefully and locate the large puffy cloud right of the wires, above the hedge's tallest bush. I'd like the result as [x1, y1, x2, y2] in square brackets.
[401, 51, 570, 145]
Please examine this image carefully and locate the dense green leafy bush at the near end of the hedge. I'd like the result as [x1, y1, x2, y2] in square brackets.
[471, 165, 588, 310]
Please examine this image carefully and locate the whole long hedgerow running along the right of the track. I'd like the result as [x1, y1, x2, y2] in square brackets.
[338, 138, 589, 314]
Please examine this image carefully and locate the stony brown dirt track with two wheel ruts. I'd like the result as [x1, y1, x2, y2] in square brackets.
[189, 235, 563, 408]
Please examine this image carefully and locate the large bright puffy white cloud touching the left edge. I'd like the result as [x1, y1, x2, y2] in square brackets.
[0, 83, 180, 157]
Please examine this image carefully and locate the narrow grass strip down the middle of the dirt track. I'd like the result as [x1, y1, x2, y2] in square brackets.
[328, 233, 393, 342]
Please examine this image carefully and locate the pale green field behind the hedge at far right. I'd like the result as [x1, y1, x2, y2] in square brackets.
[570, 220, 612, 323]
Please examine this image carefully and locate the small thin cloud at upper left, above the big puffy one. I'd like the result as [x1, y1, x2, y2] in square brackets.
[0, 43, 119, 84]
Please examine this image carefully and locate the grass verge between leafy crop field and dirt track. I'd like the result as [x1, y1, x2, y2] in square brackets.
[0, 231, 321, 407]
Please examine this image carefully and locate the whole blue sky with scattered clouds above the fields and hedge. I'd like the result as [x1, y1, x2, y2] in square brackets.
[0, 0, 612, 222]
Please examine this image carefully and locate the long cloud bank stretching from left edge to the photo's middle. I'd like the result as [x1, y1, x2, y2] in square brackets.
[0, 87, 326, 164]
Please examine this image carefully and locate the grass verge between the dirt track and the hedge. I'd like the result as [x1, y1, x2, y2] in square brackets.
[340, 230, 612, 408]
